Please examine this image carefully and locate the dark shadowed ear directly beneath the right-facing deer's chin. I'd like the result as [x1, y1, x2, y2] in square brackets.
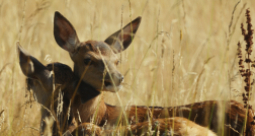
[77, 81, 100, 103]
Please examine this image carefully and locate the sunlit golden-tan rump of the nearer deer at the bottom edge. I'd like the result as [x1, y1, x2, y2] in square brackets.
[128, 117, 216, 136]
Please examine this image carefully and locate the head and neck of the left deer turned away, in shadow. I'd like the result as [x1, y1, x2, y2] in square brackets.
[17, 43, 100, 134]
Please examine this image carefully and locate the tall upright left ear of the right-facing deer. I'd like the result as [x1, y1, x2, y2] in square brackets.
[54, 11, 79, 54]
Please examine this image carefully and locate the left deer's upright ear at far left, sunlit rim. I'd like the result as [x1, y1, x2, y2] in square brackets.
[17, 43, 51, 82]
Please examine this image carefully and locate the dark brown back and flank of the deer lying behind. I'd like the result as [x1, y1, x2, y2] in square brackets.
[99, 100, 255, 136]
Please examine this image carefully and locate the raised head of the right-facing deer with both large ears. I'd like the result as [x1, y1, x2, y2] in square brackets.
[54, 12, 141, 92]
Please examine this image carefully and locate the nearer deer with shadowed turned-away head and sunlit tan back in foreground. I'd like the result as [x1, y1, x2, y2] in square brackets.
[18, 47, 216, 136]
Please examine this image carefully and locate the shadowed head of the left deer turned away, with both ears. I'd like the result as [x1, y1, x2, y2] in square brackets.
[17, 43, 100, 105]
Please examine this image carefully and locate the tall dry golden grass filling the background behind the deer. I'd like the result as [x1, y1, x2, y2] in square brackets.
[0, 0, 255, 136]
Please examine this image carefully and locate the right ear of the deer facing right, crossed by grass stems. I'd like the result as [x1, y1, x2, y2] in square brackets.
[104, 17, 141, 53]
